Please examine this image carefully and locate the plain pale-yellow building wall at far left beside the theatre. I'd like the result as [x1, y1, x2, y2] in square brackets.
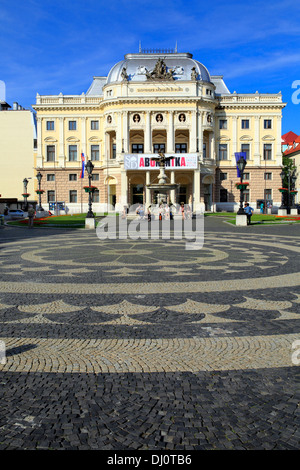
[0, 100, 37, 213]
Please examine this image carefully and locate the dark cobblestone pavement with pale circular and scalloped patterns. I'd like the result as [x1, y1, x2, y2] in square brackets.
[0, 218, 300, 451]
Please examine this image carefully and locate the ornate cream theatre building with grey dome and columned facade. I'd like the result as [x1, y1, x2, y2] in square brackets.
[33, 50, 285, 213]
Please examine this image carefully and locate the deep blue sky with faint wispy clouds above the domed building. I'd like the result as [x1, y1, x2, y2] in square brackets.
[0, 0, 300, 134]
